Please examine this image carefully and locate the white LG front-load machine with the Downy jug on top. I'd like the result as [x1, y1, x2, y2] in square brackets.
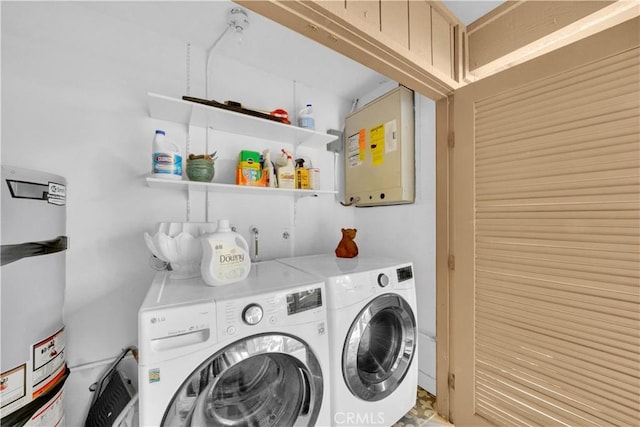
[138, 261, 331, 427]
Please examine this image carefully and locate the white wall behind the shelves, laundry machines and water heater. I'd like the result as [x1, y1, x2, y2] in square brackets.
[1, 2, 435, 425]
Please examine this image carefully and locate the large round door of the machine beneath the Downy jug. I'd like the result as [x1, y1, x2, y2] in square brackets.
[162, 334, 323, 427]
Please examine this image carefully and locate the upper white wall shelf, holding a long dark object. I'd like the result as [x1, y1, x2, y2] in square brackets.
[148, 92, 336, 149]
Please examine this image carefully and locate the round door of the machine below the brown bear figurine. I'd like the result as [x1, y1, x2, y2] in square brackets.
[342, 294, 416, 401]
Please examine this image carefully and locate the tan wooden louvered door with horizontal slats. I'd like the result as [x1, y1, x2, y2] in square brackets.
[450, 19, 640, 427]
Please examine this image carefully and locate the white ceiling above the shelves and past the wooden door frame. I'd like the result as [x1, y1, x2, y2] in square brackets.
[82, 0, 502, 99]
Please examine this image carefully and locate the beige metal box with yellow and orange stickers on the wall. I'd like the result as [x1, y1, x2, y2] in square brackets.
[344, 86, 415, 206]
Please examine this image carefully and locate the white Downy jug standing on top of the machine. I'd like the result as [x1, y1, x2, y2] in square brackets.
[200, 219, 251, 286]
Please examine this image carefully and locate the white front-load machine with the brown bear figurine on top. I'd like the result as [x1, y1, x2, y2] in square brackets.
[278, 254, 418, 426]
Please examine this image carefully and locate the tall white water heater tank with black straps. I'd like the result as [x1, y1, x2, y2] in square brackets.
[0, 165, 69, 426]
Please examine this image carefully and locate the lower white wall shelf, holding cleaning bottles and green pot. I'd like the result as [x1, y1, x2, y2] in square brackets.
[147, 177, 338, 197]
